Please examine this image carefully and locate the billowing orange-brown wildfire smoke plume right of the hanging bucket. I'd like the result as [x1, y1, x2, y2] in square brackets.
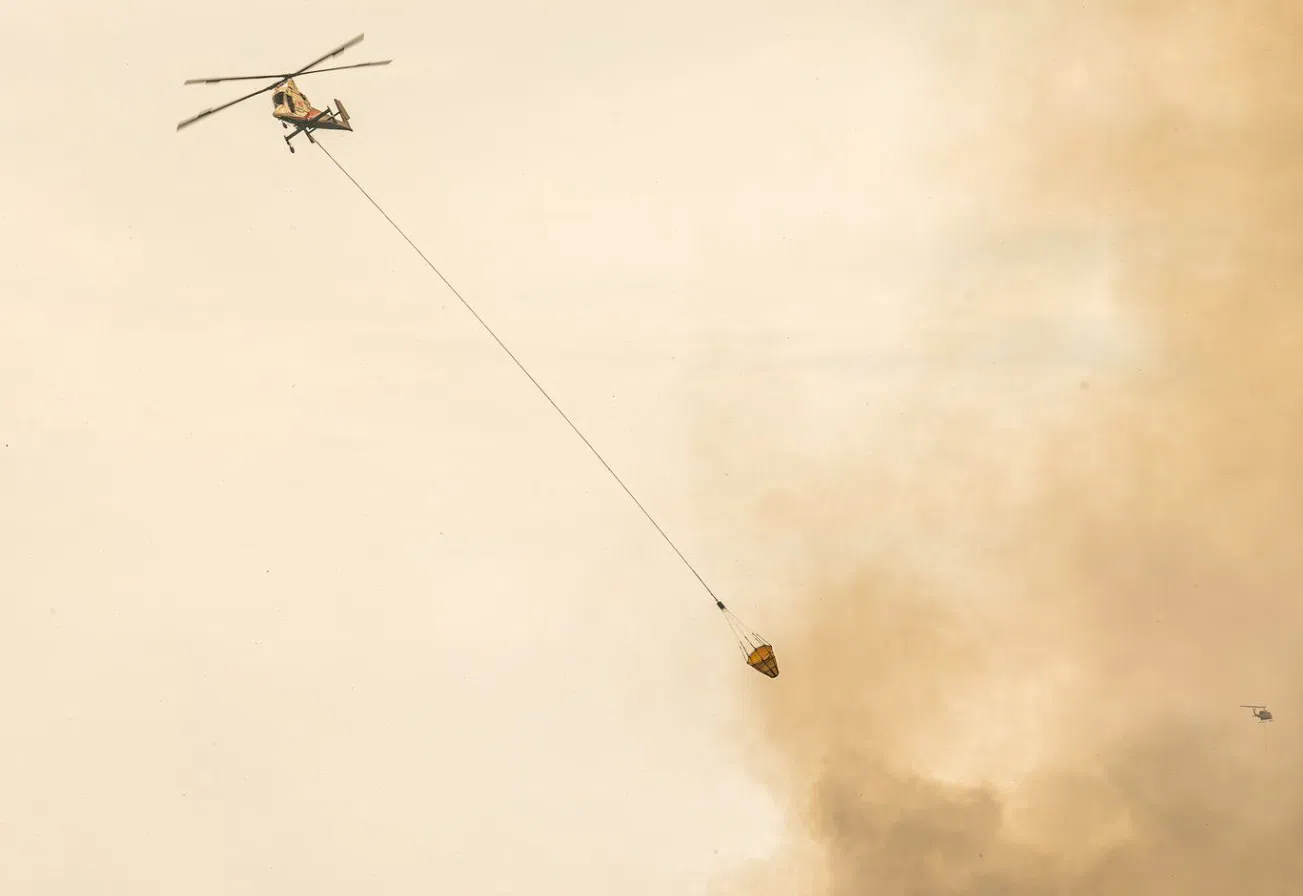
[701, 1, 1303, 896]
